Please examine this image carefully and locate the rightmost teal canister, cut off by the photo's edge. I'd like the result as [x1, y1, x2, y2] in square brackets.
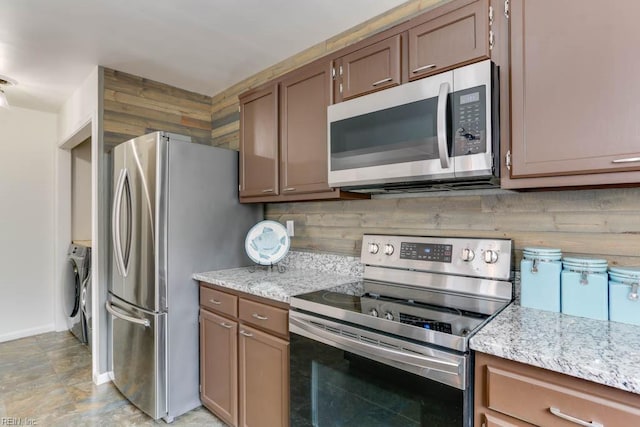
[609, 267, 640, 325]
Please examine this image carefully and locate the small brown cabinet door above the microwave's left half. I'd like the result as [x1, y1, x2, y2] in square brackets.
[335, 34, 401, 100]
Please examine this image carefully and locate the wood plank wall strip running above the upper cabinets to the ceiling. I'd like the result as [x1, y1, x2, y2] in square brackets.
[211, 0, 450, 150]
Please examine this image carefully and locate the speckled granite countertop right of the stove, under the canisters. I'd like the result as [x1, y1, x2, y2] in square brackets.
[470, 303, 640, 394]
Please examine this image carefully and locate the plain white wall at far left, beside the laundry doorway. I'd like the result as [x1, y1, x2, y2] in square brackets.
[0, 107, 57, 342]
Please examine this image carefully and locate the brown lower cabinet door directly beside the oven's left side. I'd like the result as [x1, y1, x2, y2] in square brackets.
[239, 325, 289, 427]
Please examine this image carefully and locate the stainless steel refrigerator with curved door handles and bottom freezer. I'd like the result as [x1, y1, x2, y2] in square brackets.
[106, 132, 263, 422]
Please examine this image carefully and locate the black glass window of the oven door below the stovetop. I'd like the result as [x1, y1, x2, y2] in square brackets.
[291, 333, 465, 427]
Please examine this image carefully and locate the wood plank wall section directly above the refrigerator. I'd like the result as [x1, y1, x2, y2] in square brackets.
[103, 68, 211, 151]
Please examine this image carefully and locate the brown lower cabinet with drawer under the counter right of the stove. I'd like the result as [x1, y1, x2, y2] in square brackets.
[474, 353, 640, 427]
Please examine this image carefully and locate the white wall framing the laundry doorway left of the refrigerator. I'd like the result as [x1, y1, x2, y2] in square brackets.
[54, 66, 109, 384]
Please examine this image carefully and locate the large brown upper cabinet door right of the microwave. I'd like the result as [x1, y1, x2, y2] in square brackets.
[510, 0, 640, 180]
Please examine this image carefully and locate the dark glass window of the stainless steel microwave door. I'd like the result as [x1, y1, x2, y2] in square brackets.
[330, 97, 451, 171]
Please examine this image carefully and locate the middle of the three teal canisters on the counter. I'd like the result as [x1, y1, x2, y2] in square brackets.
[560, 258, 609, 320]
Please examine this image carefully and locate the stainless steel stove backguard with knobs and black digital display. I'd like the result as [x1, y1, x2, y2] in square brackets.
[361, 234, 513, 280]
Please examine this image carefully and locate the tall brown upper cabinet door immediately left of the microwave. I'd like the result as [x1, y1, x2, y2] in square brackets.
[280, 61, 331, 195]
